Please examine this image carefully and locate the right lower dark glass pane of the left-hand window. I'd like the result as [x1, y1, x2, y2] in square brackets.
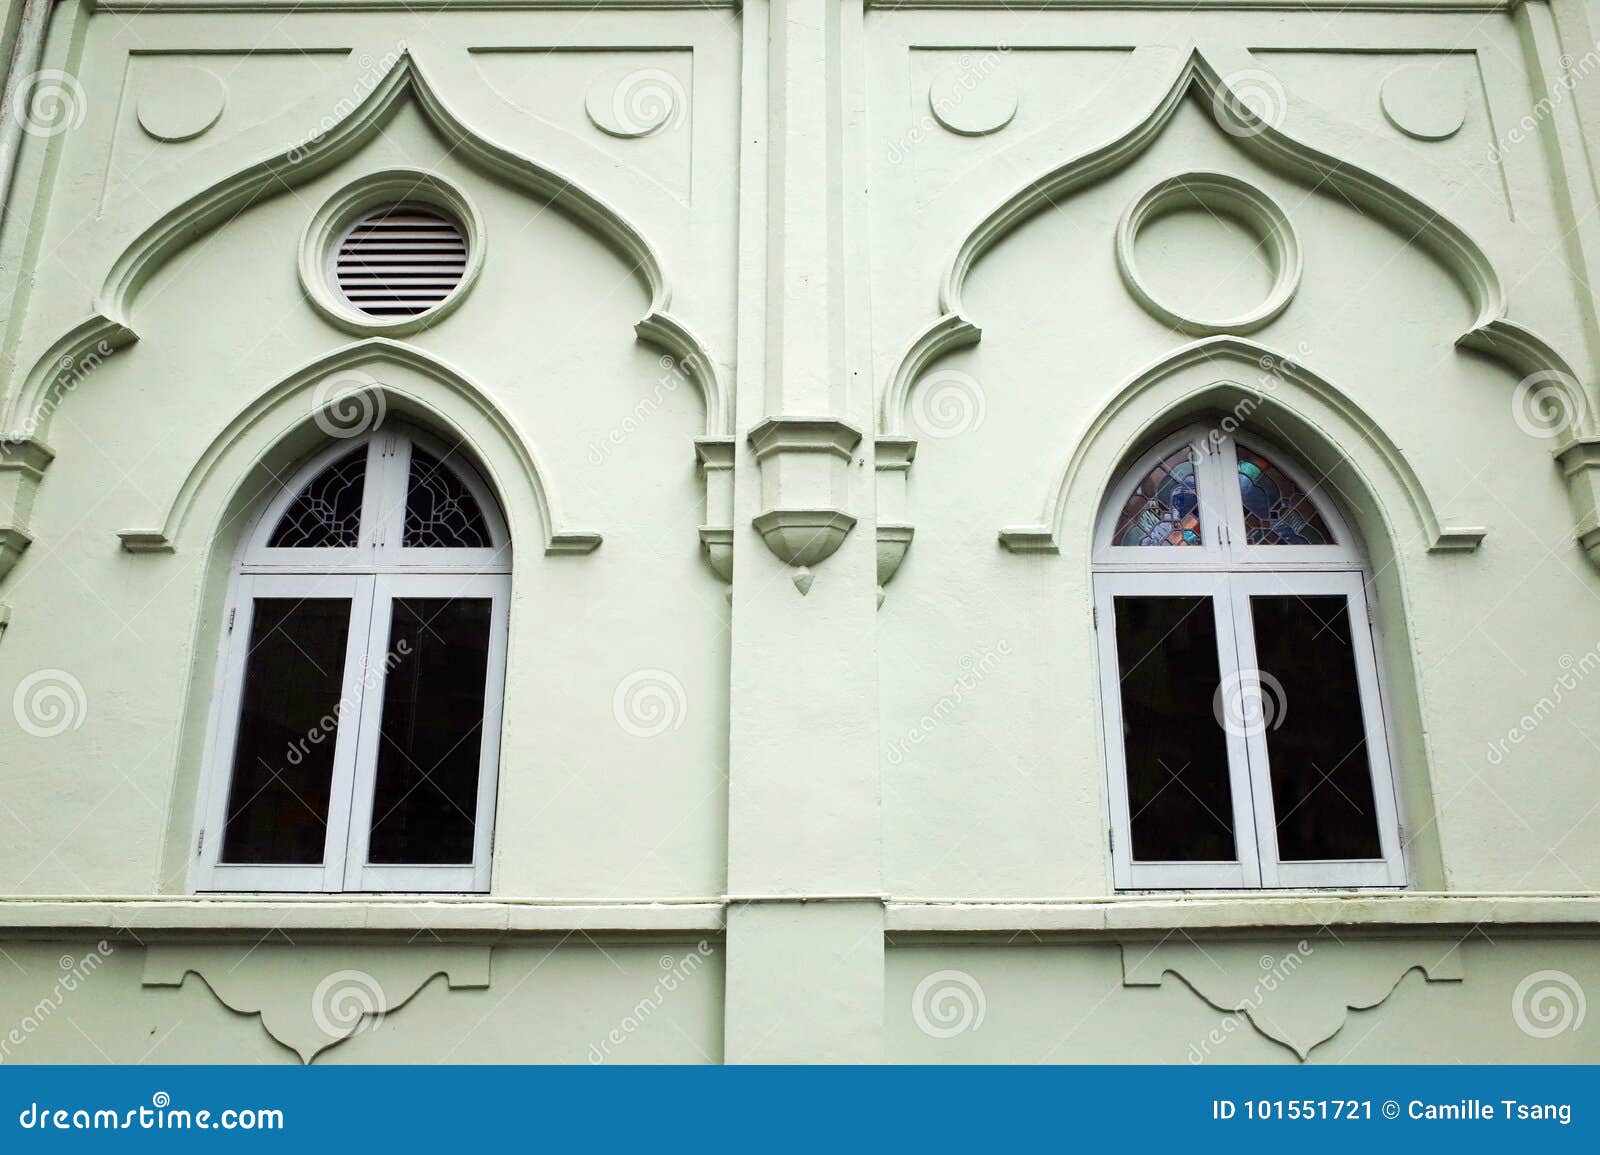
[368, 598, 493, 864]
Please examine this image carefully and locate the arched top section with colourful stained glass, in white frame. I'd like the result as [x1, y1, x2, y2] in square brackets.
[1094, 426, 1363, 568]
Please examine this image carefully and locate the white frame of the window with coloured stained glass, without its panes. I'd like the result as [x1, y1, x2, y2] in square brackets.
[1093, 426, 1406, 889]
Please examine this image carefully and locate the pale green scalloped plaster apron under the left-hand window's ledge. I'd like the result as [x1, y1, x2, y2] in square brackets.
[142, 942, 490, 1062]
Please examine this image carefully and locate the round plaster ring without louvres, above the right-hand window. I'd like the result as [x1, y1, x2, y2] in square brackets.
[1117, 173, 1301, 336]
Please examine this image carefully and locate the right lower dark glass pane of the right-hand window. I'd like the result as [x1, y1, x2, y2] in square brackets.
[1250, 595, 1381, 862]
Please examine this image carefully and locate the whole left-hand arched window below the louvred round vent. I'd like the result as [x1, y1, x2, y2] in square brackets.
[195, 426, 510, 891]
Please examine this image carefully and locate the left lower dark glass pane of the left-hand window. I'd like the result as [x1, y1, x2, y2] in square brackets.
[222, 598, 350, 864]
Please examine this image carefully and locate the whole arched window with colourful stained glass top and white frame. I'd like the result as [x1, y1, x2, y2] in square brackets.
[1094, 427, 1405, 888]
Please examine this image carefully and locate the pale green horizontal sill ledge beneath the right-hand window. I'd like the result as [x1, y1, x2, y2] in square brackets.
[885, 891, 1600, 939]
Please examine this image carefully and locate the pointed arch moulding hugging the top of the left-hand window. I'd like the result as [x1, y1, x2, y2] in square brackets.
[117, 338, 600, 554]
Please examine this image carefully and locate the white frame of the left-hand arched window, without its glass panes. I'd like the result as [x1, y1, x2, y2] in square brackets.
[190, 424, 510, 893]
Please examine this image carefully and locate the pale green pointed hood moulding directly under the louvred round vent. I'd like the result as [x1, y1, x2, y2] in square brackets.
[117, 338, 600, 555]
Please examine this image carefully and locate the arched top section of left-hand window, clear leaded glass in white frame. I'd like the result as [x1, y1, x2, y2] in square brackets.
[242, 424, 510, 571]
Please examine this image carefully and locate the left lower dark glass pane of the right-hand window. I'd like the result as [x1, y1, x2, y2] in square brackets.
[1115, 597, 1237, 862]
